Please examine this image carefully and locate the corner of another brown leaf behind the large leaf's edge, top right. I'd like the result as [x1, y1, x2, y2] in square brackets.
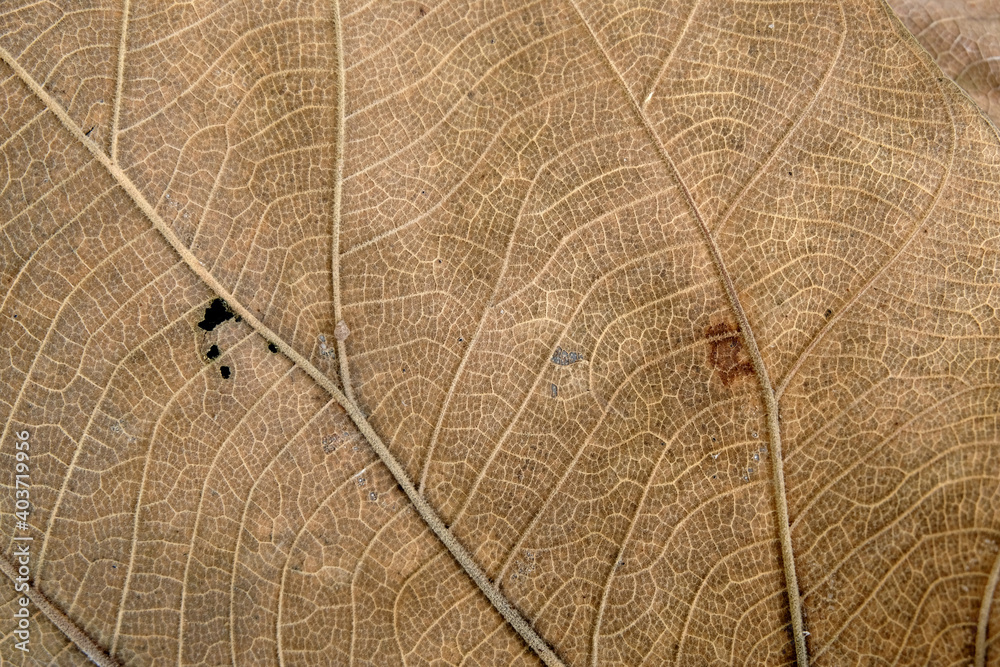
[889, 0, 1000, 124]
